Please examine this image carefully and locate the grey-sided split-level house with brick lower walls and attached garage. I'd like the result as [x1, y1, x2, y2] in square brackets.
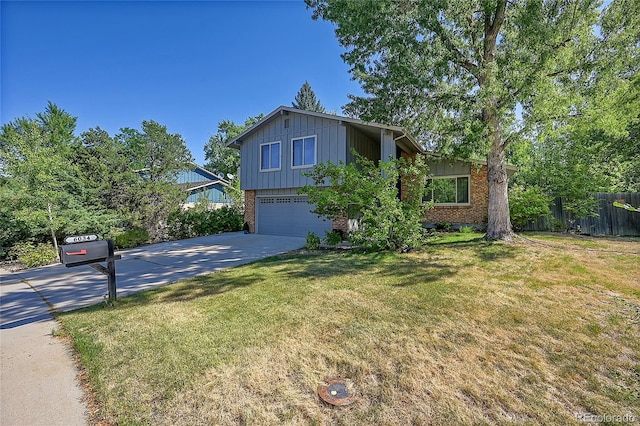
[228, 106, 512, 236]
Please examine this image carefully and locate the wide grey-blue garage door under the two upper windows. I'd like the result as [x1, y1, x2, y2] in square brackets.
[256, 196, 331, 238]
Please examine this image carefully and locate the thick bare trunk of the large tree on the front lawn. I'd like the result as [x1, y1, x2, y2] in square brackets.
[485, 141, 514, 241]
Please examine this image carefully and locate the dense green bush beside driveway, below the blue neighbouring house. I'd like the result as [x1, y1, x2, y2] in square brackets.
[168, 205, 244, 240]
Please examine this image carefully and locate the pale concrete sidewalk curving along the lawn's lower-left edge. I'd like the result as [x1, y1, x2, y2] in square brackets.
[0, 273, 87, 426]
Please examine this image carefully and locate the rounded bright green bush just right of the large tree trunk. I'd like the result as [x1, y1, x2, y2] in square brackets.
[509, 185, 551, 229]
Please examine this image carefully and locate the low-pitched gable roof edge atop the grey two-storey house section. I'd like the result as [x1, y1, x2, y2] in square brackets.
[227, 106, 425, 152]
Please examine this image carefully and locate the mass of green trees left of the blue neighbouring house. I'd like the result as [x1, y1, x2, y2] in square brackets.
[0, 102, 192, 256]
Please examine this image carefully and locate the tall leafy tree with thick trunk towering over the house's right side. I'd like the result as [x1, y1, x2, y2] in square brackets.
[306, 0, 637, 239]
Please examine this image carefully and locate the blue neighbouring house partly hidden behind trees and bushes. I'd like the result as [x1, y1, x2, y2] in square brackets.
[177, 164, 232, 208]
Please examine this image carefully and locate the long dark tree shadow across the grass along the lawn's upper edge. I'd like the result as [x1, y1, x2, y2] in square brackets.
[60, 240, 523, 309]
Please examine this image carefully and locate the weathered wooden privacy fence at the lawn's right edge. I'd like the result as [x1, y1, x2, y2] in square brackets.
[524, 192, 640, 237]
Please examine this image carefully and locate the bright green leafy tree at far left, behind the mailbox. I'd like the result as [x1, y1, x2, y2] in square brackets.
[0, 102, 96, 251]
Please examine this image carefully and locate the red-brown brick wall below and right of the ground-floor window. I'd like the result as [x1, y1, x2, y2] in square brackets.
[426, 165, 489, 225]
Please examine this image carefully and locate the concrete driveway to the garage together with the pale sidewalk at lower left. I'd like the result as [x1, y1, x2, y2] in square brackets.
[0, 232, 305, 426]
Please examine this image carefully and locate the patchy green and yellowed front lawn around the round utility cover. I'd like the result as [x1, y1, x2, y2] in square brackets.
[59, 235, 640, 425]
